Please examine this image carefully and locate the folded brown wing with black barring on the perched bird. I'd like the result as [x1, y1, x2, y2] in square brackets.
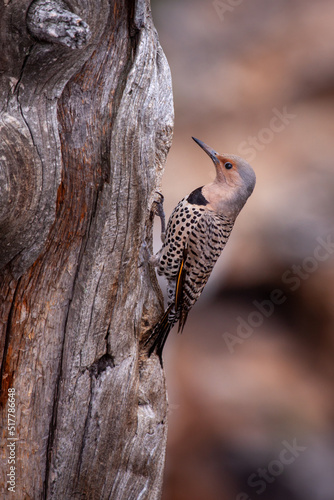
[175, 210, 233, 331]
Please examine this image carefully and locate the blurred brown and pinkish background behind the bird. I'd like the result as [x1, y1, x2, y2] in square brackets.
[152, 0, 334, 500]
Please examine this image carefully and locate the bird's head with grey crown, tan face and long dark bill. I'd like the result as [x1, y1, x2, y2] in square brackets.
[193, 137, 256, 218]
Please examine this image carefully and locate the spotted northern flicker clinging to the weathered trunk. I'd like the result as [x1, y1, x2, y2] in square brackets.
[146, 137, 256, 362]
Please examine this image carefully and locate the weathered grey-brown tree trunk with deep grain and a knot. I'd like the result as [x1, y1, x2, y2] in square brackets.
[0, 0, 173, 499]
